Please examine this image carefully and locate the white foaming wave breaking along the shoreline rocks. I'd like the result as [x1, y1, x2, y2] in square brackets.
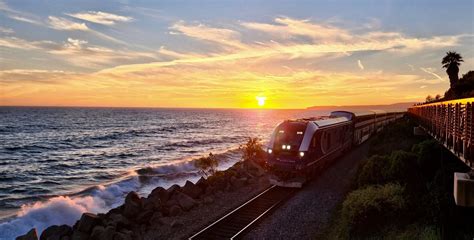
[0, 148, 240, 240]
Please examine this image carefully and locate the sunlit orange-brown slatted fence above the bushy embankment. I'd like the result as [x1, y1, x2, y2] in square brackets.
[408, 98, 474, 169]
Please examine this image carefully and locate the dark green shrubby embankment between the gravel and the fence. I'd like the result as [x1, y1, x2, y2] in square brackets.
[319, 119, 474, 239]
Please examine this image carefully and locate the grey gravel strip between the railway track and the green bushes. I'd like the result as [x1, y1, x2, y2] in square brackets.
[244, 143, 369, 239]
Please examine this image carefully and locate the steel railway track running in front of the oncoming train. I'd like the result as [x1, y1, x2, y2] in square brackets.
[189, 185, 296, 240]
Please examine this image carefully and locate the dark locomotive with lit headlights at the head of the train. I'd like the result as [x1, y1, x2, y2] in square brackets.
[267, 116, 352, 187]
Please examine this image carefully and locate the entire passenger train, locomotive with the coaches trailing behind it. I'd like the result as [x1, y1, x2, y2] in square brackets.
[266, 110, 405, 187]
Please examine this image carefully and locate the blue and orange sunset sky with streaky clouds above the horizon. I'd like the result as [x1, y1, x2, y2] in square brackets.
[0, 0, 474, 108]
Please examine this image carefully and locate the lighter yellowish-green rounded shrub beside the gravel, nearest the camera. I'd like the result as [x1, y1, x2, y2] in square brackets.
[341, 183, 405, 238]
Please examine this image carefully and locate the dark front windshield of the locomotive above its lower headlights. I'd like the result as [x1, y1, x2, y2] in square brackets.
[275, 122, 307, 150]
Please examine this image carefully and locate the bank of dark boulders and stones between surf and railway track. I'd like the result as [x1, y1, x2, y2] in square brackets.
[16, 160, 269, 240]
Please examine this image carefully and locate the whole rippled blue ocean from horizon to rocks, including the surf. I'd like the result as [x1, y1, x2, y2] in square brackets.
[0, 107, 328, 239]
